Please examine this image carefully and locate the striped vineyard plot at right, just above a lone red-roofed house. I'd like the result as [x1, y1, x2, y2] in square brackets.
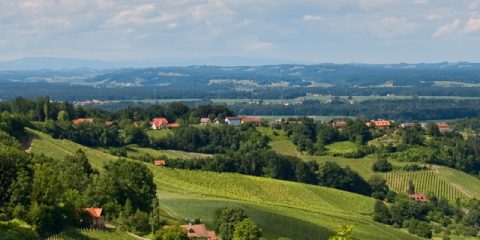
[381, 171, 467, 201]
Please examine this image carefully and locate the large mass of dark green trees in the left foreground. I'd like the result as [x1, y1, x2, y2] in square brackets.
[0, 117, 161, 236]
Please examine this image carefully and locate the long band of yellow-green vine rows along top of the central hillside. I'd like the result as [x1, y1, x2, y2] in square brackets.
[152, 167, 373, 214]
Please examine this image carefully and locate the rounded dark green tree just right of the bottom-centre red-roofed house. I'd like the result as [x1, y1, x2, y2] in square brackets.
[215, 207, 247, 240]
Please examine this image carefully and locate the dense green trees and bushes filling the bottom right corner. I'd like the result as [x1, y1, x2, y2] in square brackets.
[373, 194, 480, 239]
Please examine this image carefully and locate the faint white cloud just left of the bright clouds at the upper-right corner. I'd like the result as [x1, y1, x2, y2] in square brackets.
[371, 17, 417, 38]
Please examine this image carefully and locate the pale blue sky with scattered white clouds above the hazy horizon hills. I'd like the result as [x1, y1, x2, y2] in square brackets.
[0, 0, 480, 63]
